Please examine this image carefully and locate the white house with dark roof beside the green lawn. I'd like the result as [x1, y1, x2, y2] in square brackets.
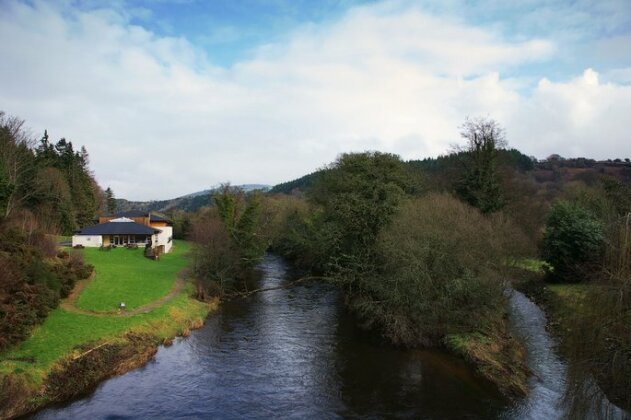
[72, 210, 173, 254]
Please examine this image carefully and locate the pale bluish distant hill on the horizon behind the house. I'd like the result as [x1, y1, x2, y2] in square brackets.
[116, 184, 270, 213]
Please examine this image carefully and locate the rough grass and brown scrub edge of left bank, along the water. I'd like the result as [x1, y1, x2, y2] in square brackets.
[0, 288, 218, 418]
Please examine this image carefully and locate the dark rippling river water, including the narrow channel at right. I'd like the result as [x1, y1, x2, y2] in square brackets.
[35, 255, 576, 419]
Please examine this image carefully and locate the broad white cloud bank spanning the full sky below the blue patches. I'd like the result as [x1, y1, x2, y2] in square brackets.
[0, 2, 631, 199]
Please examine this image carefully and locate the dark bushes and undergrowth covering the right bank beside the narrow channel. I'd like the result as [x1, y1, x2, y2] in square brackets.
[526, 177, 631, 417]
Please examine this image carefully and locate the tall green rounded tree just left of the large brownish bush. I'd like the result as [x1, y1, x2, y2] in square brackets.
[309, 152, 420, 277]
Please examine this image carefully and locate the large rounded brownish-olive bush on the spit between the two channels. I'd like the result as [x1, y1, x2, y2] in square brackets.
[351, 194, 529, 346]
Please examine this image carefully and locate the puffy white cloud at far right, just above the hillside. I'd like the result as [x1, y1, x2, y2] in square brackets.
[509, 69, 631, 158]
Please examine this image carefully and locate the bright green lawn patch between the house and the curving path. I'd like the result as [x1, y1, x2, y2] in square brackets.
[76, 241, 190, 312]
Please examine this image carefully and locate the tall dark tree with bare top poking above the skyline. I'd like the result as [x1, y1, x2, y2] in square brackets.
[456, 118, 507, 213]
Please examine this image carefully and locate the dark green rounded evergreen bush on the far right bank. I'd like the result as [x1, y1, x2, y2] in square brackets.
[543, 200, 604, 283]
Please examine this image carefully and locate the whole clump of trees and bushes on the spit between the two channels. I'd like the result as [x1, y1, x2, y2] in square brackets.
[262, 146, 534, 395]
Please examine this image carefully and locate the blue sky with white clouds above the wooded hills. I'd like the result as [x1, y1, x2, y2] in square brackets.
[0, 0, 631, 200]
